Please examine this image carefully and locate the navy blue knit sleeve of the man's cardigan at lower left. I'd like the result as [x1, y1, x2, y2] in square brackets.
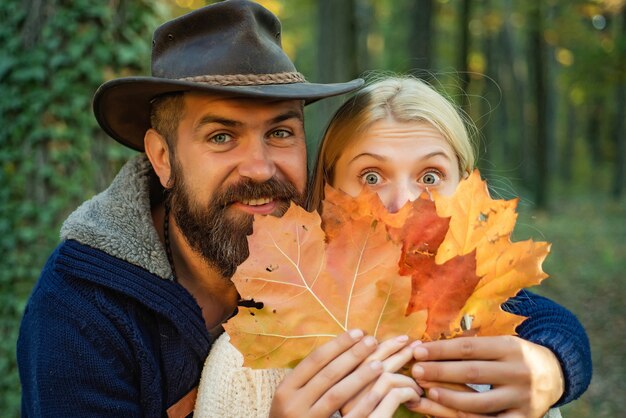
[17, 266, 144, 417]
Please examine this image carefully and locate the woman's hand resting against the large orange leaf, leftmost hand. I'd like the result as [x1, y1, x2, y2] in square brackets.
[270, 330, 383, 418]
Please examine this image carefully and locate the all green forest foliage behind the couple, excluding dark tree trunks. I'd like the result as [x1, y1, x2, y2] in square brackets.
[0, 0, 626, 418]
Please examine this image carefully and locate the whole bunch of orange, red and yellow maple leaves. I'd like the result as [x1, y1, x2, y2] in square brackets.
[225, 171, 550, 368]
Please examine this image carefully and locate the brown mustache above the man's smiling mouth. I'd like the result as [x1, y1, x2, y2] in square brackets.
[215, 177, 302, 208]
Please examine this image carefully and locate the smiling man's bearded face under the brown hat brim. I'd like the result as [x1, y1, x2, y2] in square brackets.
[171, 94, 306, 277]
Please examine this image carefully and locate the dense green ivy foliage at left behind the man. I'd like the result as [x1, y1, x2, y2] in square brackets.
[0, 0, 165, 416]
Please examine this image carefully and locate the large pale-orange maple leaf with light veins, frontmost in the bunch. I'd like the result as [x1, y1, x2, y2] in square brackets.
[225, 205, 426, 368]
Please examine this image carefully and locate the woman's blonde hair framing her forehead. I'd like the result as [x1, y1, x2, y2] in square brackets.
[308, 76, 475, 210]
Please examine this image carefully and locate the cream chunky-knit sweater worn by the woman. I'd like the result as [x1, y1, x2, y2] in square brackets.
[194, 332, 561, 418]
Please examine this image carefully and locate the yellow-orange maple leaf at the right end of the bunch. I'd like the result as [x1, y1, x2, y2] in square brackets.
[429, 170, 550, 336]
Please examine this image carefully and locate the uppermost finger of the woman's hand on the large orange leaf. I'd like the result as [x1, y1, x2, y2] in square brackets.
[283, 329, 364, 389]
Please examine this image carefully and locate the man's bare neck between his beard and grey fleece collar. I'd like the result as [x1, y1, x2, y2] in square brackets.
[152, 205, 239, 331]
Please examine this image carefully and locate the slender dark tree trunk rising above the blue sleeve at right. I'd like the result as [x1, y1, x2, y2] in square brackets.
[529, 0, 549, 209]
